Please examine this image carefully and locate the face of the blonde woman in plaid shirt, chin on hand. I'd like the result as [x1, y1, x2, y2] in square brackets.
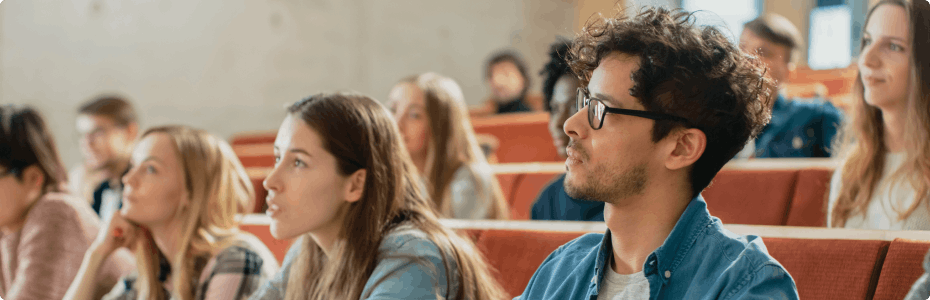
[120, 133, 189, 225]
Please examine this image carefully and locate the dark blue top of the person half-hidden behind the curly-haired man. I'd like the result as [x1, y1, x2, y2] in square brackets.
[530, 174, 604, 221]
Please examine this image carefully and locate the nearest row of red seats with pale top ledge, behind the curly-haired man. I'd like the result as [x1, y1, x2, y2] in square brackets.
[242, 215, 930, 300]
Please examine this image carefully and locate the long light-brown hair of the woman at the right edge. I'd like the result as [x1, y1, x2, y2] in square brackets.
[828, 0, 930, 227]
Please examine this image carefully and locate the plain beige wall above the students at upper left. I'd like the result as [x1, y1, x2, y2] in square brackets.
[0, 0, 576, 165]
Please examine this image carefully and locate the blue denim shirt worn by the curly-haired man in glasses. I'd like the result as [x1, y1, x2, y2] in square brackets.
[514, 195, 798, 300]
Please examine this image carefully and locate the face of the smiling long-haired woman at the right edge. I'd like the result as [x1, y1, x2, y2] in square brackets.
[858, 4, 913, 108]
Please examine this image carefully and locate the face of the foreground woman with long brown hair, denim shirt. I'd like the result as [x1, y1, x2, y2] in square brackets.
[263, 115, 348, 239]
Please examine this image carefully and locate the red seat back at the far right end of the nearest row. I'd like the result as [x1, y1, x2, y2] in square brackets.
[873, 238, 930, 300]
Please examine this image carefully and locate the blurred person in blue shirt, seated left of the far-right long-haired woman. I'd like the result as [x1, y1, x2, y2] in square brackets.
[737, 13, 842, 158]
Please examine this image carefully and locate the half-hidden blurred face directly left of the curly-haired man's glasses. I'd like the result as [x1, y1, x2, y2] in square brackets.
[549, 75, 578, 158]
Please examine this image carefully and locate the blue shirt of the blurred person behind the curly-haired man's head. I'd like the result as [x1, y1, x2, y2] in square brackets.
[754, 95, 843, 158]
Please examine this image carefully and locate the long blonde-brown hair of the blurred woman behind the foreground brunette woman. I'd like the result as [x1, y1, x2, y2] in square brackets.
[400, 73, 510, 219]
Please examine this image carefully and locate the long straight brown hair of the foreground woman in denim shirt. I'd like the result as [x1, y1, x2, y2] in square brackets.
[285, 94, 504, 300]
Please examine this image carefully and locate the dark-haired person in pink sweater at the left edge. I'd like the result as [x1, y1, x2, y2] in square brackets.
[0, 105, 134, 300]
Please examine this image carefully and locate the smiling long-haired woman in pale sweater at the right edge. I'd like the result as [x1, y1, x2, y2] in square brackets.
[827, 0, 930, 230]
